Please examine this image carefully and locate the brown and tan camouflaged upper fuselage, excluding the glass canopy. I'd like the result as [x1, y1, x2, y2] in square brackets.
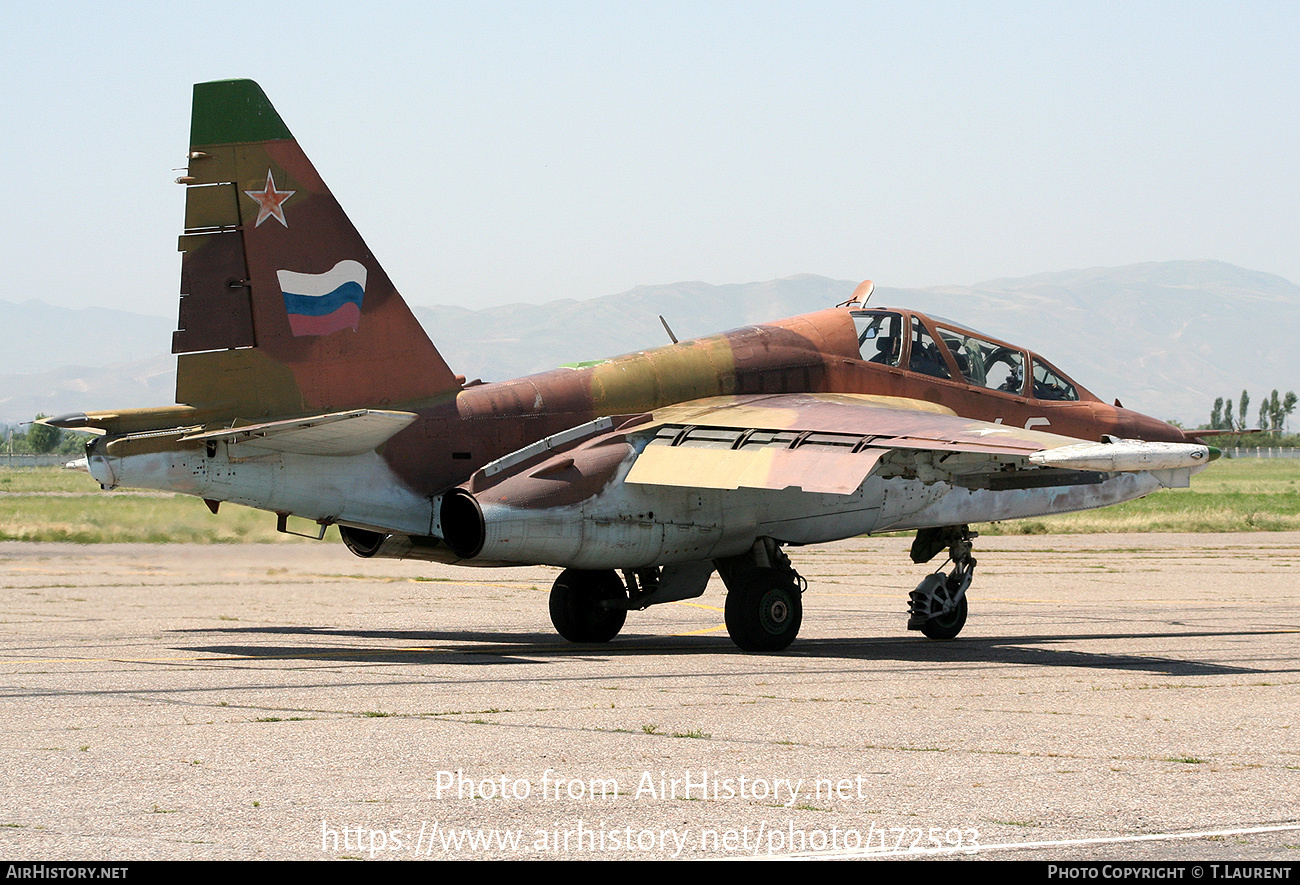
[371, 308, 1183, 494]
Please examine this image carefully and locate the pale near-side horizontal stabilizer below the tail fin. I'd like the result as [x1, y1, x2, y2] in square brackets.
[181, 409, 416, 455]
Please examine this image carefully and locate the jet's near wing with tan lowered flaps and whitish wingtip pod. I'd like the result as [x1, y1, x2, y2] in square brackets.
[627, 394, 1212, 495]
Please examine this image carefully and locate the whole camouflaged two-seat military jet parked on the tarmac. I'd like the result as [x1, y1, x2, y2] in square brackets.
[49, 81, 1217, 651]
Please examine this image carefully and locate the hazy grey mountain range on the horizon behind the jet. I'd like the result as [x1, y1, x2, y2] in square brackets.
[0, 261, 1300, 426]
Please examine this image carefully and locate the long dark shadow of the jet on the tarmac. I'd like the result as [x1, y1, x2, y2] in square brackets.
[176, 626, 1297, 677]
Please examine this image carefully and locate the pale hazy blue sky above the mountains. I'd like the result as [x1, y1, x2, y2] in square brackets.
[0, 0, 1300, 314]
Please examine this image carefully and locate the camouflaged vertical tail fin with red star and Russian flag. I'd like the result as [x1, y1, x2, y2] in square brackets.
[172, 81, 463, 418]
